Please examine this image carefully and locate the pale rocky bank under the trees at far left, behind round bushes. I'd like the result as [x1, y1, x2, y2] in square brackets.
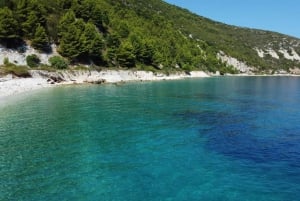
[0, 45, 58, 65]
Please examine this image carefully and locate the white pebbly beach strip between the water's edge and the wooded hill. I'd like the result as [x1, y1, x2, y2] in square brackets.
[0, 70, 209, 99]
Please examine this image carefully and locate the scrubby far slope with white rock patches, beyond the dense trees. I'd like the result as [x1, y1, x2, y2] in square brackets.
[132, 0, 300, 71]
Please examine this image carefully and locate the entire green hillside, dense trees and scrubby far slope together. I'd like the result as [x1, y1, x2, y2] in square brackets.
[0, 0, 300, 73]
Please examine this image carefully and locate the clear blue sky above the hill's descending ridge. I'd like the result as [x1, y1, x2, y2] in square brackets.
[165, 0, 300, 38]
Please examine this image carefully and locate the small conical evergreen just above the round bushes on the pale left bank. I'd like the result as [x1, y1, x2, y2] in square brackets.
[31, 26, 49, 51]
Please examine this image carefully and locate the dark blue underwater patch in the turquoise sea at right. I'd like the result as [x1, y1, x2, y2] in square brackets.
[177, 110, 300, 168]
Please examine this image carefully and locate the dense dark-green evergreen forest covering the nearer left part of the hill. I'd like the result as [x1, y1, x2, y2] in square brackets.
[0, 0, 234, 71]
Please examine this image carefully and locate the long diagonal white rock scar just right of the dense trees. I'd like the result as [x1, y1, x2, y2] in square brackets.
[217, 52, 255, 73]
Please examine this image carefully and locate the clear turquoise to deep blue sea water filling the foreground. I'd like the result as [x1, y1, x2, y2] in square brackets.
[0, 77, 300, 201]
